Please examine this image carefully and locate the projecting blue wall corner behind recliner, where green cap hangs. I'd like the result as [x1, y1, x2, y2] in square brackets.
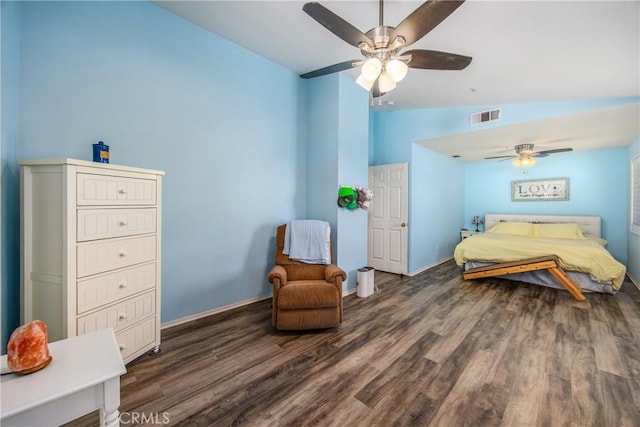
[306, 74, 369, 289]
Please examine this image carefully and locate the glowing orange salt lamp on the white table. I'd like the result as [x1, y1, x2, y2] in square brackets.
[7, 320, 53, 375]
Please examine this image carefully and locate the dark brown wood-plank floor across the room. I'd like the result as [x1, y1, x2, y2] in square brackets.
[70, 261, 640, 427]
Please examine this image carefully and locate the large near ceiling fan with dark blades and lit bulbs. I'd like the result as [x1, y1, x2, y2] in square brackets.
[300, 0, 472, 98]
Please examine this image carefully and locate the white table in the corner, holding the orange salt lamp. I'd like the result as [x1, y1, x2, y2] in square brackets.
[0, 329, 127, 427]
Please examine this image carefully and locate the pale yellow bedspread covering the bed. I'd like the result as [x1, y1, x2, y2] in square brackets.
[454, 233, 626, 290]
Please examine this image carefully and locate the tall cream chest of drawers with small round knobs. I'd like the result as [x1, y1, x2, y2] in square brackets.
[19, 159, 164, 363]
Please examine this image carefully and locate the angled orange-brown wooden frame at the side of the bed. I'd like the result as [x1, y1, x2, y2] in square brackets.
[462, 255, 585, 301]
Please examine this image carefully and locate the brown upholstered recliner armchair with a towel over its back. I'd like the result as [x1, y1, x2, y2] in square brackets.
[269, 225, 347, 330]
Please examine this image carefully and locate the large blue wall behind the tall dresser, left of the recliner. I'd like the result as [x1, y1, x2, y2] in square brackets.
[11, 2, 306, 328]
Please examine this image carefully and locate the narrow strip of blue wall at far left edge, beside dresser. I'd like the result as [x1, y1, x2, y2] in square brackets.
[0, 2, 20, 353]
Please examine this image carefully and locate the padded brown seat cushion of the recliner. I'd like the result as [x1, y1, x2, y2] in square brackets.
[278, 280, 340, 309]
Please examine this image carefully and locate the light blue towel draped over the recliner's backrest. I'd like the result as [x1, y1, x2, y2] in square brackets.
[282, 219, 331, 264]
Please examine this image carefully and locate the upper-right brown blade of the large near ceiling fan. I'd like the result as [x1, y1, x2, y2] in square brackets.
[390, 0, 464, 46]
